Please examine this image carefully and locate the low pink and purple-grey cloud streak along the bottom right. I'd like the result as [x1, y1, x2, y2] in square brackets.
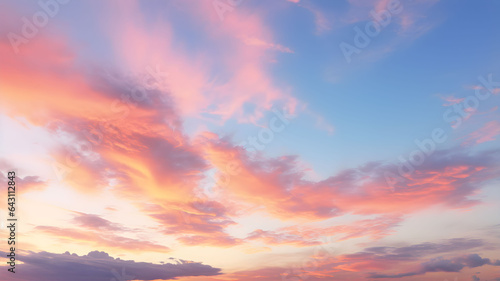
[152, 237, 496, 281]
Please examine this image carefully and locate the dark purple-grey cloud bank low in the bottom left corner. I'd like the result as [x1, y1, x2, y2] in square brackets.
[0, 251, 221, 281]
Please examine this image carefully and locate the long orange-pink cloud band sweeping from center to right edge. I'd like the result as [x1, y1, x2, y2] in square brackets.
[201, 133, 497, 220]
